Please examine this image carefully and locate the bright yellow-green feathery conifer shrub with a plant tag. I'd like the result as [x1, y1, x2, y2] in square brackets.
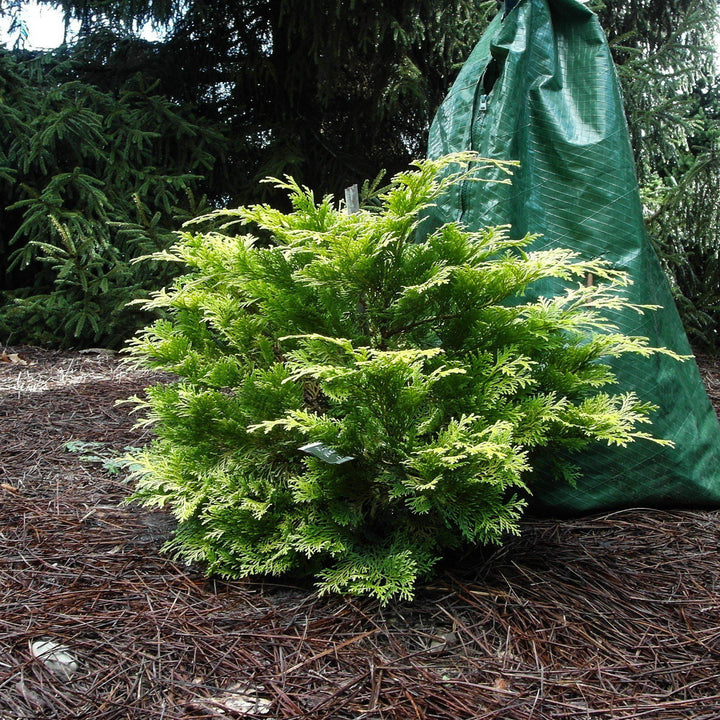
[124, 153, 680, 602]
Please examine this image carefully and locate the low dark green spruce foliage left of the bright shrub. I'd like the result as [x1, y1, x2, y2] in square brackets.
[0, 51, 222, 347]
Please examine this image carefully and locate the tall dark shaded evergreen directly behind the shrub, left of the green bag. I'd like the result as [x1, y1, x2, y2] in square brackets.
[45, 0, 496, 205]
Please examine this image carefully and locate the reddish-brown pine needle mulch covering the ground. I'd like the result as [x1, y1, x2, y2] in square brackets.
[0, 348, 720, 720]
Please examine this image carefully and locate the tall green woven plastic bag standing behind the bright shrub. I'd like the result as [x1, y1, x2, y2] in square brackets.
[428, 0, 720, 514]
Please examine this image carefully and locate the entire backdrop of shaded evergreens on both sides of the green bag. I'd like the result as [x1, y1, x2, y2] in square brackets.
[0, 0, 720, 346]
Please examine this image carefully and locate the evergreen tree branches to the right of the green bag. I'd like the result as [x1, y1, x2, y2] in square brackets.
[591, 0, 720, 348]
